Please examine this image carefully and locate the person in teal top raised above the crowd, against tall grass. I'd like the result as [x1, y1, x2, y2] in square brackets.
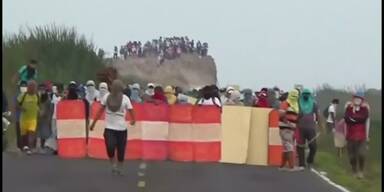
[13, 59, 38, 85]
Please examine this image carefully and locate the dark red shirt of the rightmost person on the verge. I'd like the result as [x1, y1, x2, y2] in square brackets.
[344, 105, 369, 141]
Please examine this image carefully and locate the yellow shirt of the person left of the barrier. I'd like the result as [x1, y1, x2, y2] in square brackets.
[17, 93, 39, 121]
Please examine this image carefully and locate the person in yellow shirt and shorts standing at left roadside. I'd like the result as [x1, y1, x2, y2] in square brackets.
[17, 80, 39, 155]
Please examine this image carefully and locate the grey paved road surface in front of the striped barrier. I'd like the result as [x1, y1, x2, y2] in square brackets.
[3, 153, 339, 192]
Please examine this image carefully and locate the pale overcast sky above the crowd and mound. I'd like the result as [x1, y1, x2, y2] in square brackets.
[3, 0, 381, 89]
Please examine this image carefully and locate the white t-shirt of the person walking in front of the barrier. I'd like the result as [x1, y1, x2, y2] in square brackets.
[101, 93, 133, 131]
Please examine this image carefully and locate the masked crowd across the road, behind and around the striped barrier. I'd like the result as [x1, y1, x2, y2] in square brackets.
[3, 60, 369, 178]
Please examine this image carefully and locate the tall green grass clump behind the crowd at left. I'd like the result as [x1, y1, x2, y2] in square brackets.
[2, 24, 103, 93]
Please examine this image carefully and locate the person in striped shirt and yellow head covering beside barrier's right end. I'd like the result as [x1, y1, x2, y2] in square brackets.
[279, 90, 302, 171]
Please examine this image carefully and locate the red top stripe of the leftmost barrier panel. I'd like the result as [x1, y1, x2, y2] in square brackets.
[56, 100, 85, 120]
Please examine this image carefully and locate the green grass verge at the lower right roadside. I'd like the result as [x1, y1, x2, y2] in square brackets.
[315, 121, 381, 192]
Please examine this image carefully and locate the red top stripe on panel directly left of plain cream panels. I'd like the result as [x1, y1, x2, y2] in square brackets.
[192, 106, 221, 124]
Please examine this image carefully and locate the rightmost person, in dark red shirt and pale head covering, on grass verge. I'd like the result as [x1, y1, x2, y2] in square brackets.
[344, 92, 369, 179]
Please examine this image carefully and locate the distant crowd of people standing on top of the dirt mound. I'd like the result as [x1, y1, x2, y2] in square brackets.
[113, 37, 208, 62]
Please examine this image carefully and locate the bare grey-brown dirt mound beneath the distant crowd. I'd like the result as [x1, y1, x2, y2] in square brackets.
[111, 54, 217, 88]
